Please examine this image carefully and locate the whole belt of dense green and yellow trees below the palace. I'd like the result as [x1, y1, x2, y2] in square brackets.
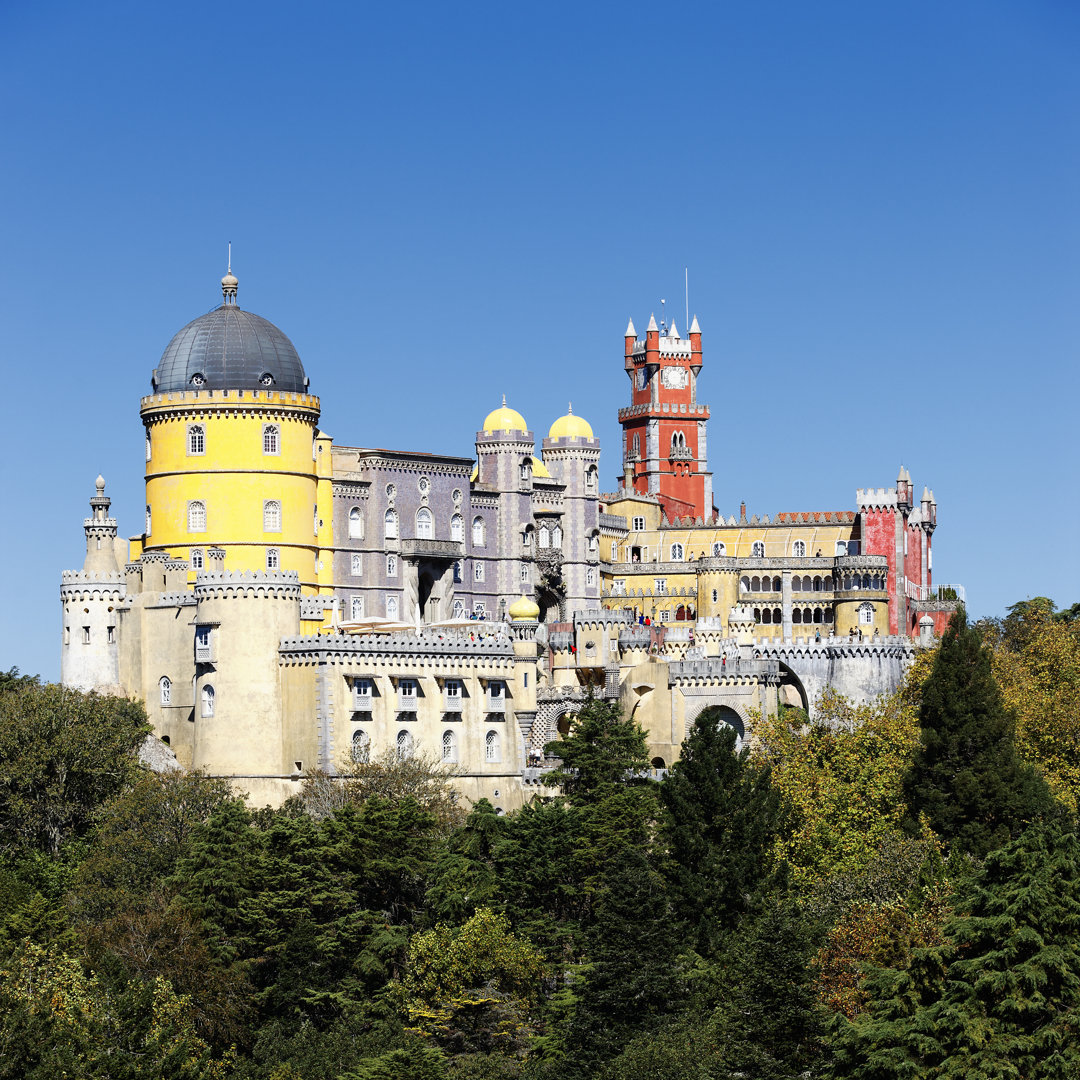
[0, 598, 1080, 1080]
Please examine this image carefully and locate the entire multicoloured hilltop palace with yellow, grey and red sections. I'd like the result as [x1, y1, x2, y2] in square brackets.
[60, 269, 963, 810]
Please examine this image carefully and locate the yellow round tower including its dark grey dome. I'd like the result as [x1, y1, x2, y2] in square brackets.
[139, 267, 320, 593]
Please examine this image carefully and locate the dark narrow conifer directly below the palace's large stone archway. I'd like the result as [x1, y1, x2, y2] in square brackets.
[660, 708, 783, 956]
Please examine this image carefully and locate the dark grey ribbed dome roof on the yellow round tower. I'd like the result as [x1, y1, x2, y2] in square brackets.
[152, 303, 308, 393]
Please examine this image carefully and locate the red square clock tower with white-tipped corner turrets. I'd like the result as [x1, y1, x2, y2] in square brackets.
[619, 315, 713, 522]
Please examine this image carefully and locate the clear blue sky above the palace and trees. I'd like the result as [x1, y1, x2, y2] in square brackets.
[0, 0, 1080, 678]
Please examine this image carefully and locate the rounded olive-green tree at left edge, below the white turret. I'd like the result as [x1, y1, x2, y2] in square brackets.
[0, 680, 150, 854]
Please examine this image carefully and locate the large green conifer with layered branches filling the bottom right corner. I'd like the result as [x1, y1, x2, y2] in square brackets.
[831, 822, 1080, 1080]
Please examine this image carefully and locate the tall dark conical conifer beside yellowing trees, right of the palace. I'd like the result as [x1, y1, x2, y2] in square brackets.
[904, 609, 1053, 856]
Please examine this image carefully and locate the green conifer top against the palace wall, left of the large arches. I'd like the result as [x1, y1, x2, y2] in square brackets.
[544, 698, 649, 802]
